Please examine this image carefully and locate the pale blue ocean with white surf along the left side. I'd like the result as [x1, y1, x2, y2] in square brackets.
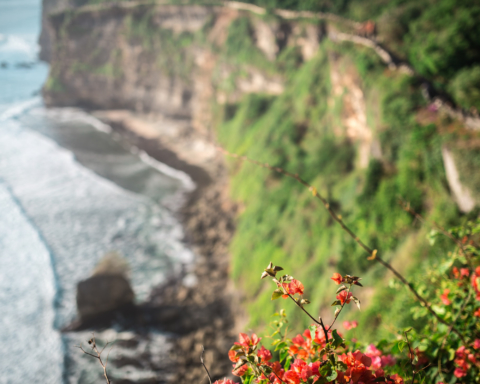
[0, 0, 195, 384]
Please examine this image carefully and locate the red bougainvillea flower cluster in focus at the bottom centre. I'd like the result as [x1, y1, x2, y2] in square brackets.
[219, 263, 403, 384]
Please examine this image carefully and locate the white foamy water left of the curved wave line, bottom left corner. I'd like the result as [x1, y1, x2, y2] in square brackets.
[0, 182, 63, 384]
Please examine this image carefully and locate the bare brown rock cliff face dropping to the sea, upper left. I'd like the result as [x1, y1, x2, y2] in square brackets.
[44, 0, 321, 133]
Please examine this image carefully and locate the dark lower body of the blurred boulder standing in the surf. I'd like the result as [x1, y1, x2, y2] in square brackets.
[77, 275, 135, 322]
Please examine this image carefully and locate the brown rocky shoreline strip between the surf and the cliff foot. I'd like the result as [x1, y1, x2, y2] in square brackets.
[91, 111, 244, 383]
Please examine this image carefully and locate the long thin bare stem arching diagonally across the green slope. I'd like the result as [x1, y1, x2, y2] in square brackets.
[217, 146, 463, 340]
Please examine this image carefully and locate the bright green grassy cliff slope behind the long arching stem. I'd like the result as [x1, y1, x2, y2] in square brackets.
[218, 40, 470, 338]
